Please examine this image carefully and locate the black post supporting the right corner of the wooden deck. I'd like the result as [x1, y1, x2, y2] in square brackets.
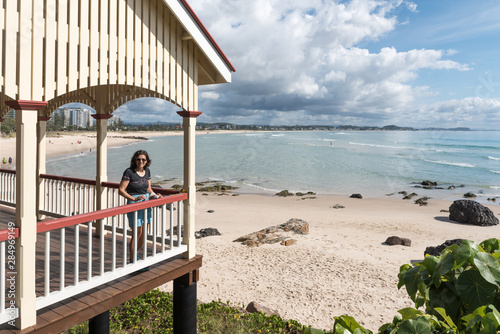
[174, 276, 197, 334]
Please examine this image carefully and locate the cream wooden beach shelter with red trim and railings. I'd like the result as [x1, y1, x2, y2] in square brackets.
[0, 0, 235, 331]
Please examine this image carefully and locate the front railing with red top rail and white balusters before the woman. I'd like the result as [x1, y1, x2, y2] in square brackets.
[0, 194, 188, 323]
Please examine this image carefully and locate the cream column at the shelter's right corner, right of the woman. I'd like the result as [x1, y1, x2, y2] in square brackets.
[178, 111, 201, 259]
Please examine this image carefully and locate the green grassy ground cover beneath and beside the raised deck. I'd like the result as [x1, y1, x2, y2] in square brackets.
[64, 290, 325, 334]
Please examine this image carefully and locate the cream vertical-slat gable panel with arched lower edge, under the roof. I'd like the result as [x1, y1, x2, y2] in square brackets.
[0, 0, 227, 117]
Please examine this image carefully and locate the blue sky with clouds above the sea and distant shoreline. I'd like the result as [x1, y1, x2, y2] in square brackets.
[109, 0, 500, 129]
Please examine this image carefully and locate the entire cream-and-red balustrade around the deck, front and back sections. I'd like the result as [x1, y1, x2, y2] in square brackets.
[0, 169, 188, 324]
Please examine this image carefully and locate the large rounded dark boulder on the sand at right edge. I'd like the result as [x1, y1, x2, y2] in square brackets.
[449, 199, 498, 226]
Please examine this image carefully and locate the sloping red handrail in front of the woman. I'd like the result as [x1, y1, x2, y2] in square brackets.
[37, 193, 188, 233]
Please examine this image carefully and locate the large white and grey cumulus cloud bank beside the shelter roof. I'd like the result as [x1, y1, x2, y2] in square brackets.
[180, 0, 500, 128]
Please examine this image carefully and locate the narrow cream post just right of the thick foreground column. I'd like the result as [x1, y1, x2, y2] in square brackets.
[36, 116, 50, 219]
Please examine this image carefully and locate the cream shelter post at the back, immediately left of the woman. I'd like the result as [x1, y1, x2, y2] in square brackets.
[92, 114, 113, 235]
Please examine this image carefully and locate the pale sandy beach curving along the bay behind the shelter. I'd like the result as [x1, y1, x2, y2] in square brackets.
[0, 132, 500, 331]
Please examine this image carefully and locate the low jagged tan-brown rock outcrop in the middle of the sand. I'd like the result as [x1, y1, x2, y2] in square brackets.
[234, 218, 309, 247]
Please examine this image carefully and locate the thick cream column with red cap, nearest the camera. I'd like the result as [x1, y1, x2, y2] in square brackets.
[6, 100, 47, 329]
